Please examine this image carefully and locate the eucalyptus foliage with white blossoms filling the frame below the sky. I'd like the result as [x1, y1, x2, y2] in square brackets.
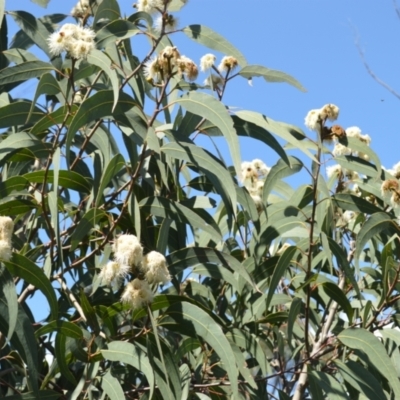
[0, 0, 400, 400]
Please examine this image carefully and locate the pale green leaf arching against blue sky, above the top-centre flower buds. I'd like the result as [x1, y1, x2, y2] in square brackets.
[183, 25, 247, 67]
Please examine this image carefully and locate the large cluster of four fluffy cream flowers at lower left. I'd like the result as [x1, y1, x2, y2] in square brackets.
[100, 235, 171, 309]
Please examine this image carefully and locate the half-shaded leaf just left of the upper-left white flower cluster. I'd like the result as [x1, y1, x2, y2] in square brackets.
[8, 11, 52, 58]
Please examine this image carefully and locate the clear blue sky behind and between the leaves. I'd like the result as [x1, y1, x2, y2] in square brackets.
[6, 0, 400, 319]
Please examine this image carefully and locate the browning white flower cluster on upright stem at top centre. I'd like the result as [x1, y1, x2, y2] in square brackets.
[144, 46, 199, 82]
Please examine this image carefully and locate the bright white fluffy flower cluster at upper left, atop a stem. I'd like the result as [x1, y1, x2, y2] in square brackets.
[47, 24, 96, 60]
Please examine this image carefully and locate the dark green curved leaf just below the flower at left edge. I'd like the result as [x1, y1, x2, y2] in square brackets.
[4, 253, 58, 319]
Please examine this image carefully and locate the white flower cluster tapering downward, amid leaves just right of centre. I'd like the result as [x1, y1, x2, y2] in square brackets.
[241, 159, 271, 210]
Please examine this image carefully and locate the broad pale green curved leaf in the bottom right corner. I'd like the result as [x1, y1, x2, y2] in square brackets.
[335, 328, 400, 398]
